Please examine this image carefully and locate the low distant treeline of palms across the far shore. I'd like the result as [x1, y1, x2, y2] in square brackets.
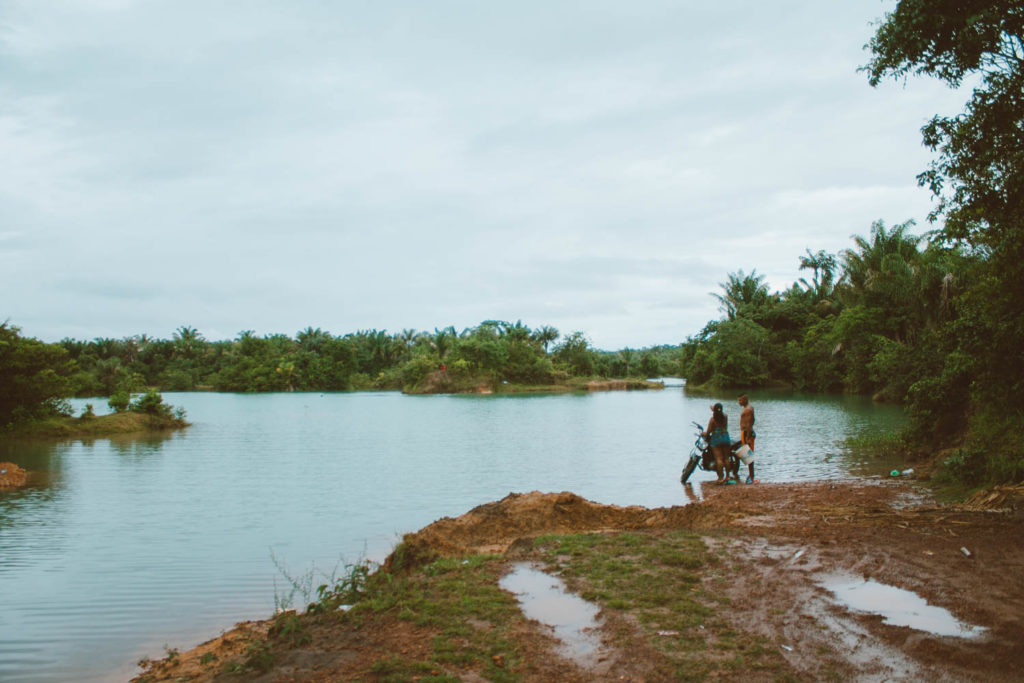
[44, 321, 679, 396]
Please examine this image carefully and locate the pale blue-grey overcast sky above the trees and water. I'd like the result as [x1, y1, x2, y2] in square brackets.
[0, 0, 965, 349]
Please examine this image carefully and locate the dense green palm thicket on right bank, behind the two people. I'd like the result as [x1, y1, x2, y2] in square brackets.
[682, 221, 970, 419]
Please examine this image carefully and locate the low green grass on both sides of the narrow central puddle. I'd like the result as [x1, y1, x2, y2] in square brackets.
[251, 530, 785, 682]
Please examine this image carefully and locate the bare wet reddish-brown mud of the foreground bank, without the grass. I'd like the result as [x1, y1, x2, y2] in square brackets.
[135, 481, 1024, 682]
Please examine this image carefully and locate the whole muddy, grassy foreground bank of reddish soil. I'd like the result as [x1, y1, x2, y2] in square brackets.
[134, 481, 1024, 682]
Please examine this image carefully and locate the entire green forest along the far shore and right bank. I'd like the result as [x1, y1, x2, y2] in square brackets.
[0, 0, 1024, 485]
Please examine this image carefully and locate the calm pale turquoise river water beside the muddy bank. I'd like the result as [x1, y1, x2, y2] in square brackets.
[0, 382, 901, 682]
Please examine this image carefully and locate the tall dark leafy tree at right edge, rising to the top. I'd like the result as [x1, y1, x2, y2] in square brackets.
[864, 0, 1024, 480]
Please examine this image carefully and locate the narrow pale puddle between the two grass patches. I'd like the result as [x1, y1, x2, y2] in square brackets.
[499, 562, 601, 668]
